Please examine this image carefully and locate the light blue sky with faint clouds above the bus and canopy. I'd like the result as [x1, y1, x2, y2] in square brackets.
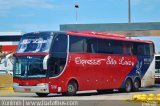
[0, 0, 160, 32]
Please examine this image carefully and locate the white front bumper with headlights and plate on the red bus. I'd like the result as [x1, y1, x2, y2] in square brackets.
[13, 83, 49, 93]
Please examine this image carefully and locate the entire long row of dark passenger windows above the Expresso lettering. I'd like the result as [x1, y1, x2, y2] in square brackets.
[70, 36, 154, 56]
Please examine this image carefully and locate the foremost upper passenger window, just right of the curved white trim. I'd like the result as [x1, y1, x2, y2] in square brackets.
[69, 36, 85, 53]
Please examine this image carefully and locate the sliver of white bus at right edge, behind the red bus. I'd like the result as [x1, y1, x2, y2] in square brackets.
[155, 54, 160, 83]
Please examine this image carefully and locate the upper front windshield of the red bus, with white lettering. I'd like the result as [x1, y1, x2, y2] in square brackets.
[17, 34, 53, 53]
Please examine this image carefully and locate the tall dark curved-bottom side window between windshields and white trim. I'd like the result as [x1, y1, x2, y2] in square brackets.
[48, 34, 67, 77]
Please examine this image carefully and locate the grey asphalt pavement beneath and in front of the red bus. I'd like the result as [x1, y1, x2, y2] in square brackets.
[0, 84, 160, 106]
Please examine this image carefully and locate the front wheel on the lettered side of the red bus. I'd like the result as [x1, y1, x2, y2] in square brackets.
[66, 81, 78, 96]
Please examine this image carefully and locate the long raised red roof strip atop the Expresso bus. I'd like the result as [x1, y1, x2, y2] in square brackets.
[66, 31, 153, 43]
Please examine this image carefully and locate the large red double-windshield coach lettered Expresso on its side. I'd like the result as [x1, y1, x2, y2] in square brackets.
[13, 31, 155, 97]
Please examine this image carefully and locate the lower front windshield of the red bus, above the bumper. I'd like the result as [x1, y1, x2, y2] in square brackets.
[14, 56, 47, 78]
